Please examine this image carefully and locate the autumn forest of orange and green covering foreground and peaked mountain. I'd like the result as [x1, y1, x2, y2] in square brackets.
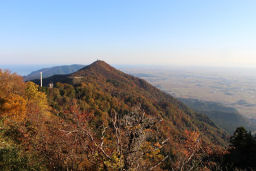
[0, 61, 256, 170]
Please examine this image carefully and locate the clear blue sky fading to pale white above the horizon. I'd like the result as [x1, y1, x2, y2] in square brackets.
[0, 0, 256, 67]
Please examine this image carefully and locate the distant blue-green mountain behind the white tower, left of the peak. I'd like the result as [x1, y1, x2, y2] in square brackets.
[23, 64, 85, 81]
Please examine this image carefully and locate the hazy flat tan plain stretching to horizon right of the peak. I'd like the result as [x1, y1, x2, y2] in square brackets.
[121, 67, 256, 119]
